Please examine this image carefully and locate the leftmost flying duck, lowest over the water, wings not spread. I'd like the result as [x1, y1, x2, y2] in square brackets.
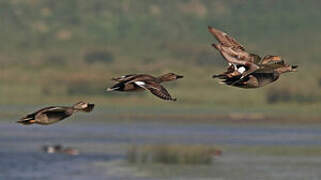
[17, 101, 95, 125]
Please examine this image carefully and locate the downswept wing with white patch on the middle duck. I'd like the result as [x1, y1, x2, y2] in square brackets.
[134, 81, 176, 101]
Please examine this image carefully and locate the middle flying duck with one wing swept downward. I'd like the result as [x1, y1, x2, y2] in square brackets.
[107, 73, 183, 101]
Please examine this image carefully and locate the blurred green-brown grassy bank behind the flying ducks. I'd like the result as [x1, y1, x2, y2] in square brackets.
[0, 0, 321, 122]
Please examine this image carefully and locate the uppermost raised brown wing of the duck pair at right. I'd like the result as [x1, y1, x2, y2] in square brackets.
[208, 26, 245, 51]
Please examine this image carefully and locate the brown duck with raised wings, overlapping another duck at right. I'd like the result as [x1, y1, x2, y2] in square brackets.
[208, 26, 296, 79]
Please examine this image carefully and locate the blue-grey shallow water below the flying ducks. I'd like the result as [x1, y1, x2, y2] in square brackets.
[0, 122, 321, 180]
